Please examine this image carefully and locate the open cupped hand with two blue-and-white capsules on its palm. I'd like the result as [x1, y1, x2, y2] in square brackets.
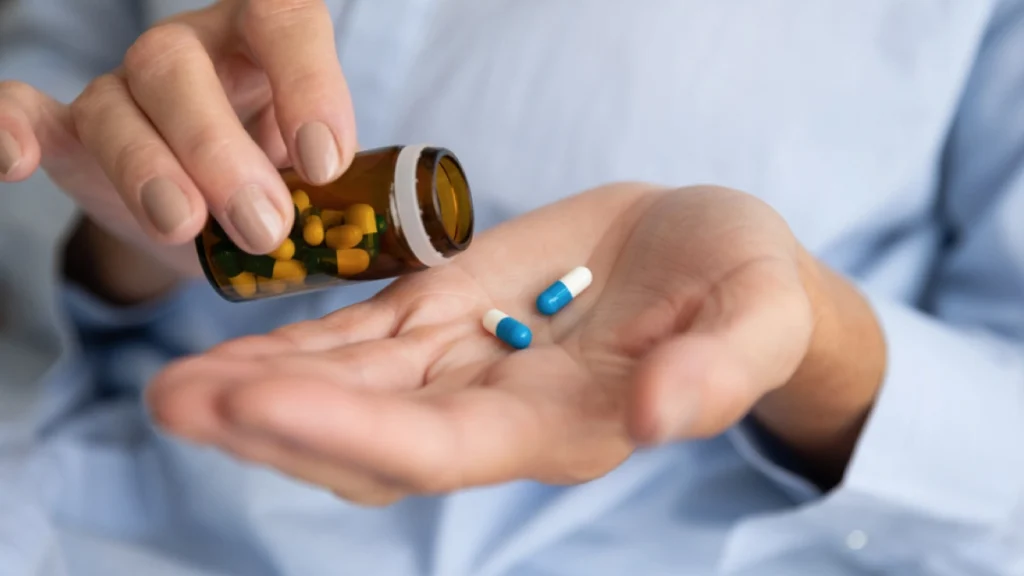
[147, 184, 813, 504]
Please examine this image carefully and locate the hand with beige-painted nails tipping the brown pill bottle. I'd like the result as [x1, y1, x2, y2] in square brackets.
[0, 0, 356, 301]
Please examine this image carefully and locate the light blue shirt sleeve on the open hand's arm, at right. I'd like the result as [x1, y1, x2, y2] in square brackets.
[727, 0, 1024, 574]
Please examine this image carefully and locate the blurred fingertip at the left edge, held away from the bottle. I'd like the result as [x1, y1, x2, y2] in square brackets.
[0, 81, 76, 182]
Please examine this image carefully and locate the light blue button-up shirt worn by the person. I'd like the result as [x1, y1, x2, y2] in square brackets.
[0, 0, 1024, 576]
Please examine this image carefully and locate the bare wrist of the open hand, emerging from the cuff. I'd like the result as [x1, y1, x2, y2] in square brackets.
[753, 243, 886, 487]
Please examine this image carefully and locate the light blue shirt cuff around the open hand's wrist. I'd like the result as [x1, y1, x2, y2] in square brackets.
[727, 292, 1024, 568]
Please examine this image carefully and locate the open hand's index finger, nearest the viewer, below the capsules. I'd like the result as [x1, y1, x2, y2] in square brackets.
[219, 379, 545, 494]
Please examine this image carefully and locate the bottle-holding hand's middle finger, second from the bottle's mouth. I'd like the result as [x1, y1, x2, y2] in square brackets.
[125, 24, 294, 253]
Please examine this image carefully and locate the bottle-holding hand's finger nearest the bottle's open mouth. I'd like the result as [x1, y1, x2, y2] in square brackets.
[239, 0, 356, 184]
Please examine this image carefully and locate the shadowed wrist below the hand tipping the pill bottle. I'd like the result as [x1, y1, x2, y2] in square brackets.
[62, 217, 181, 305]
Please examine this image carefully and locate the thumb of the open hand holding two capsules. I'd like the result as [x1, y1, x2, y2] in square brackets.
[629, 259, 813, 444]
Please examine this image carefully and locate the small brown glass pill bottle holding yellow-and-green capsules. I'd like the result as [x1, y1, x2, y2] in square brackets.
[196, 146, 473, 302]
